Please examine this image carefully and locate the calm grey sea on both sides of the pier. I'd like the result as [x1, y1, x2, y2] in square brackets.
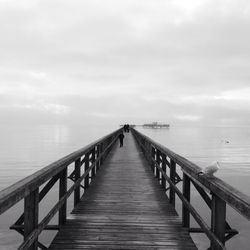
[0, 124, 250, 250]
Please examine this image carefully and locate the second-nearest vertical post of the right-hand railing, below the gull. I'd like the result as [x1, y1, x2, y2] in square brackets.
[182, 173, 190, 228]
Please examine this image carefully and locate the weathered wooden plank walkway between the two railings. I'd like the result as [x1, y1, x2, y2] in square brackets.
[50, 134, 197, 250]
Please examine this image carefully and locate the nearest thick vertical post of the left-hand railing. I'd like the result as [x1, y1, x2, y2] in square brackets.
[24, 188, 39, 250]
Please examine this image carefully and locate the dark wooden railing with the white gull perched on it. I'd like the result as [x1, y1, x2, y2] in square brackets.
[131, 129, 250, 250]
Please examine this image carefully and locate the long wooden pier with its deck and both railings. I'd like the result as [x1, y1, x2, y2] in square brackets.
[0, 129, 250, 250]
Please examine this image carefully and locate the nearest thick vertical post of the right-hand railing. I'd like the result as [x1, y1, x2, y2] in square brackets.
[211, 194, 226, 250]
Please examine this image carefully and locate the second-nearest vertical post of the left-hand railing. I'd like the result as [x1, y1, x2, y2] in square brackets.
[59, 167, 68, 226]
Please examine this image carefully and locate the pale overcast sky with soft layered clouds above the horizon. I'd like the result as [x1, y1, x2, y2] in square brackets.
[0, 0, 250, 125]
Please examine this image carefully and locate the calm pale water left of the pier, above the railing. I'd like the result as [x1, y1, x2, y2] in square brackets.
[0, 125, 117, 189]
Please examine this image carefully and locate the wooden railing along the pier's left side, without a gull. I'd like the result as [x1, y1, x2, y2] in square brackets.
[0, 129, 121, 250]
